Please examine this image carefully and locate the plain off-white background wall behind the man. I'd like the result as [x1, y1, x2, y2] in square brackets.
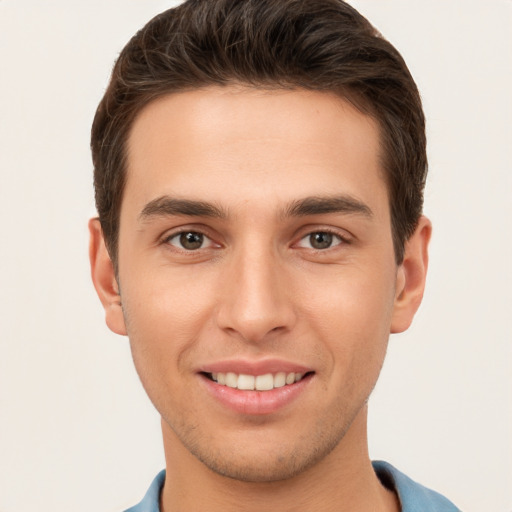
[0, 0, 512, 512]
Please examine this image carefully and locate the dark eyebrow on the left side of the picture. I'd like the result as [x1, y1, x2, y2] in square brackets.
[139, 196, 227, 221]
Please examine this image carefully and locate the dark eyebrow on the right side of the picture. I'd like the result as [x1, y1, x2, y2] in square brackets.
[284, 195, 373, 218]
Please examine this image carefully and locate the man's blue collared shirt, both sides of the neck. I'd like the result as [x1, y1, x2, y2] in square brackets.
[125, 461, 460, 512]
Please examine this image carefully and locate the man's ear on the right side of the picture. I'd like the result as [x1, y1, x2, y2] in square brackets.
[391, 216, 432, 333]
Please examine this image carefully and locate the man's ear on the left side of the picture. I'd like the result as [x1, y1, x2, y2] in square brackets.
[89, 218, 126, 335]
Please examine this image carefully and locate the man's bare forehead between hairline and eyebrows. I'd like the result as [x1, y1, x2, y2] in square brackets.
[123, 87, 387, 216]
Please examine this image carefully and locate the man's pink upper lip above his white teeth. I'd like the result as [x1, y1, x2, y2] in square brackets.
[199, 359, 313, 375]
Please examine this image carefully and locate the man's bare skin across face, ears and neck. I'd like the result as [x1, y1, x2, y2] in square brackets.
[90, 87, 431, 512]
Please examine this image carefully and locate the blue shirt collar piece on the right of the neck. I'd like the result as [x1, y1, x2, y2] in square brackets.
[373, 461, 460, 512]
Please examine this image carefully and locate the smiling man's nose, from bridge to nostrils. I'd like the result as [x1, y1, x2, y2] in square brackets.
[217, 244, 296, 343]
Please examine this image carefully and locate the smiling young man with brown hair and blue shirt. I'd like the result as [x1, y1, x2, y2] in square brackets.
[90, 0, 457, 512]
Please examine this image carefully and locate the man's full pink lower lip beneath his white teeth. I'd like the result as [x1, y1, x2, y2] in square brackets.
[201, 374, 313, 415]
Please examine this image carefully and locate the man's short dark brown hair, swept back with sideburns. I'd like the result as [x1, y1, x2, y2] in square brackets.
[91, 0, 427, 267]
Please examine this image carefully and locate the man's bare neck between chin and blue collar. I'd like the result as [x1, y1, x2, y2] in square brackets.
[160, 407, 399, 512]
